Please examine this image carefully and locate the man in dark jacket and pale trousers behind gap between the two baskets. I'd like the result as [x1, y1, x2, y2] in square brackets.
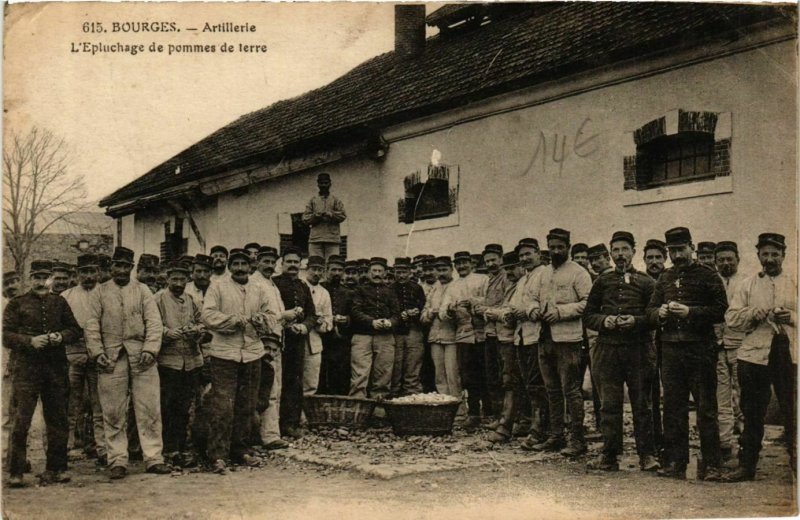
[350, 257, 401, 398]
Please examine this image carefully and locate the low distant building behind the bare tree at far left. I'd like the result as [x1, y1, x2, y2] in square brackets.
[3, 211, 114, 272]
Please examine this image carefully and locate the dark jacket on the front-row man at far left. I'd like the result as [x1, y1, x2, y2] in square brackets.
[3, 291, 83, 364]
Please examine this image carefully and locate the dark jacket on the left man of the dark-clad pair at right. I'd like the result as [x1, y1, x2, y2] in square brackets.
[583, 267, 655, 344]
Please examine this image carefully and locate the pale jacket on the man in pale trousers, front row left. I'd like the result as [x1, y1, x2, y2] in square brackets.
[84, 279, 163, 365]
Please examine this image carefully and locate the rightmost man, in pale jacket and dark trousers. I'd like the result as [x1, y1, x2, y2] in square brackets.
[725, 233, 797, 481]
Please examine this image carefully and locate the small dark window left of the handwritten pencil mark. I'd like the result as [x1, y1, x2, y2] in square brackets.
[397, 164, 457, 224]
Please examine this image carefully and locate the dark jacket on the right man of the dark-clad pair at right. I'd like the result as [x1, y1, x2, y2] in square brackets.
[647, 262, 728, 342]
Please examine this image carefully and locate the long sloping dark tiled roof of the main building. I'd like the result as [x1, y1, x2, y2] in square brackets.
[100, 2, 796, 206]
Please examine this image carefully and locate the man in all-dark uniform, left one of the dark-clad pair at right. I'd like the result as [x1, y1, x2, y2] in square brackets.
[583, 231, 660, 471]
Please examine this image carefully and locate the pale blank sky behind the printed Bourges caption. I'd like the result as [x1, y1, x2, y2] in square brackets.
[3, 3, 406, 205]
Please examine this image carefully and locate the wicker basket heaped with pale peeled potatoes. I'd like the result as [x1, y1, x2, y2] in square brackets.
[383, 401, 461, 435]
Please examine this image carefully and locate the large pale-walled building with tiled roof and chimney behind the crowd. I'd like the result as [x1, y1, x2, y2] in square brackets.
[100, 2, 797, 267]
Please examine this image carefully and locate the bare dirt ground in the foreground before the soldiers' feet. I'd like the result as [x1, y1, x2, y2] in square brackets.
[2, 408, 797, 520]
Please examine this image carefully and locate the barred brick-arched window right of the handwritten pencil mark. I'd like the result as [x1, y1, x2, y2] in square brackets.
[636, 132, 714, 188]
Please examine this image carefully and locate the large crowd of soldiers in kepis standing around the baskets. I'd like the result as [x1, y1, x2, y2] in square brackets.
[3, 223, 797, 487]
